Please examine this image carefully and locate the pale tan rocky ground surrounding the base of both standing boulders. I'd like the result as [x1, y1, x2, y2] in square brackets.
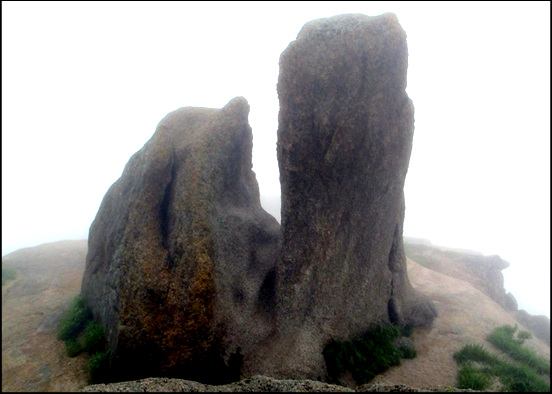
[2, 241, 550, 392]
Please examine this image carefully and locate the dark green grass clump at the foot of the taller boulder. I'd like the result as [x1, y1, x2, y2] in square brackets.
[322, 325, 416, 384]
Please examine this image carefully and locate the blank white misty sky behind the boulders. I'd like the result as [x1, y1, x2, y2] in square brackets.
[2, 1, 550, 317]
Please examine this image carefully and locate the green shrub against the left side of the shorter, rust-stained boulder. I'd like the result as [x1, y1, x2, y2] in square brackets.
[58, 294, 109, 383]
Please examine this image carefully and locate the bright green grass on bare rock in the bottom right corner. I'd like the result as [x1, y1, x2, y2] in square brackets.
[453, 325, 550, 392]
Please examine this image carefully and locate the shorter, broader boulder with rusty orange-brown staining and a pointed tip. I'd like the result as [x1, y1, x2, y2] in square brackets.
[82, 97, 280, 382]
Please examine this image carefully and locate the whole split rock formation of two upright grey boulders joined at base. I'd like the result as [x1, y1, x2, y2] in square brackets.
[82, 14, 435, 383]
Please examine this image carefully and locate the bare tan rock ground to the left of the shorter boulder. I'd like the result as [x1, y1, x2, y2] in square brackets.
[2, 241, 87, 391]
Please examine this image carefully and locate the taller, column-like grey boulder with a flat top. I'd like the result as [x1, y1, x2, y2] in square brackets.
[253, 13, 436, 379]
